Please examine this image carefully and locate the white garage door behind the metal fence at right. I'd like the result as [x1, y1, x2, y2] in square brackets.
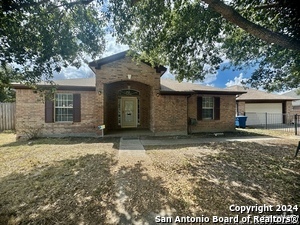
[245, 103, 283, 125]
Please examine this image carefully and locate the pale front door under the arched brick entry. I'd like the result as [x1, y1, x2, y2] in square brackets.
[121, 97, 137, 128]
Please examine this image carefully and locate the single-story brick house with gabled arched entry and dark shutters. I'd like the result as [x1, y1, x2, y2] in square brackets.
[14, 52, 245, 136]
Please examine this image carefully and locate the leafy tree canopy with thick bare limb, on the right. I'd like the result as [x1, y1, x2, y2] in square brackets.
[110, 0, 300, 91]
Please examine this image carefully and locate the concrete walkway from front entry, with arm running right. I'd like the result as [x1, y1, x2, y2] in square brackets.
[112, 136, 282, 225]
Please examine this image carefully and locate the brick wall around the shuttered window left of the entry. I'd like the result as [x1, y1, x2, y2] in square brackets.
[16, 89, 100, 137]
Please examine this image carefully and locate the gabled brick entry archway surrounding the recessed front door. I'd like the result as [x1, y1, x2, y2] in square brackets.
[93, 57, 161, 131]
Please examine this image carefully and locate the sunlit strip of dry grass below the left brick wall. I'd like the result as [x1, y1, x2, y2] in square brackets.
[0, 133, 118, 177]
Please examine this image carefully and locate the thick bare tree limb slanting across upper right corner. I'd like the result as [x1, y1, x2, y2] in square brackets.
[202, 0, 300, 51]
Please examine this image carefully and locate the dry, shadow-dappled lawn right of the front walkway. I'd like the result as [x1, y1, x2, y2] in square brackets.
[147, 140, 300, 216]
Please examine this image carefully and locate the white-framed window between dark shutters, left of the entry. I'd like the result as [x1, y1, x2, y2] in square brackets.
[55, 93, 73, 122]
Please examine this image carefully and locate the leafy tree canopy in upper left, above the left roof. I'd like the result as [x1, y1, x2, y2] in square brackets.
[0, 0, 105, 83]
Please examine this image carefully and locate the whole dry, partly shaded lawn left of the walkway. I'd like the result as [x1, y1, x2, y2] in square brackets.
[0, 134, 117, 224]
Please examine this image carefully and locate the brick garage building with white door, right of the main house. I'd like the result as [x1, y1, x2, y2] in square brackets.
[226, 85, 295, 125]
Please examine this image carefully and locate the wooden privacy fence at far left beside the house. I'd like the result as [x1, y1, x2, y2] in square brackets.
[0, 103, 16, 131]
